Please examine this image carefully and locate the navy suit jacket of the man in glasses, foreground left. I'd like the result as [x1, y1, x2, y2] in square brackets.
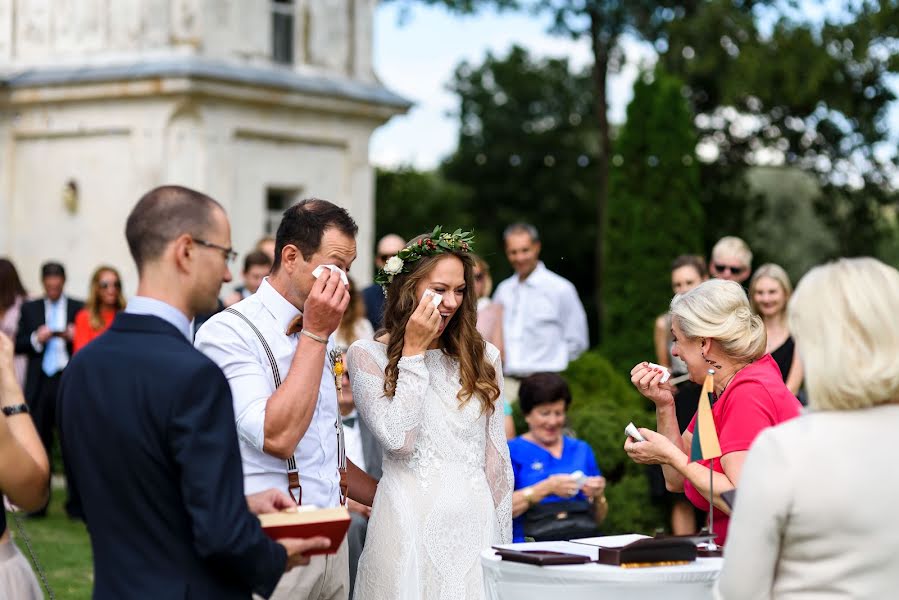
[58, 313, 287, 600]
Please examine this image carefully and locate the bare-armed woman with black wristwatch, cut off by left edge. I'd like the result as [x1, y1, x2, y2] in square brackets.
[0, 333, 50, 600]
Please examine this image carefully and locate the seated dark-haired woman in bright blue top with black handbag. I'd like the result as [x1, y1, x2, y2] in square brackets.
[509, 373, 609, 542]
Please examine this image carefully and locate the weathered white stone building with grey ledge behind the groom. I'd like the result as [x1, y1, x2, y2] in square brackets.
[0, 0, 409, 296]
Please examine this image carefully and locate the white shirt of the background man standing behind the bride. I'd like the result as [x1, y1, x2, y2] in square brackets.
[493, 262, 589, 377]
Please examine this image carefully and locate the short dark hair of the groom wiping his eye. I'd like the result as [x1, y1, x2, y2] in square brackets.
[272, 198, 359, 271]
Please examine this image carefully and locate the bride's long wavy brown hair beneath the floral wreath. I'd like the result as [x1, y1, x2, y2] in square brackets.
[378, 236, 499, 414]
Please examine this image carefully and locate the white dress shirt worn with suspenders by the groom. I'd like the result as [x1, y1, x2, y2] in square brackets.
[195, 278, 339, 507]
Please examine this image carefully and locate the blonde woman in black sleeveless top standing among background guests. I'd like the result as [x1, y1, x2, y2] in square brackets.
[749, 263, 802, 395]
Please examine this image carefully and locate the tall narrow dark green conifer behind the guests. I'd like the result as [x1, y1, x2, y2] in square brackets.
[602, 69, 705, 369]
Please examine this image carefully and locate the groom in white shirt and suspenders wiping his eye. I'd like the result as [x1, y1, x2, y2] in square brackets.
[195, 199, 376, 600]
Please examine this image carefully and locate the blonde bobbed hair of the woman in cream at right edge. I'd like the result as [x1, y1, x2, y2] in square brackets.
[788, 258, 899, 410]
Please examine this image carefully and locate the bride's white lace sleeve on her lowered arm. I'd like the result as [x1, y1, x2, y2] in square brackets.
[484, 344, 514, 544]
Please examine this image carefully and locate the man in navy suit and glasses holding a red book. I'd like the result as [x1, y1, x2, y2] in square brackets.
[59, 186, 329, 599]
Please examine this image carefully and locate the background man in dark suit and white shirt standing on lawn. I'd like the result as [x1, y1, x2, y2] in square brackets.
[16, 262, 84, 518]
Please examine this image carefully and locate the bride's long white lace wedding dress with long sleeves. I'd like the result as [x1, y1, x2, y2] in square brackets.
[347, 340, 514, 600]
